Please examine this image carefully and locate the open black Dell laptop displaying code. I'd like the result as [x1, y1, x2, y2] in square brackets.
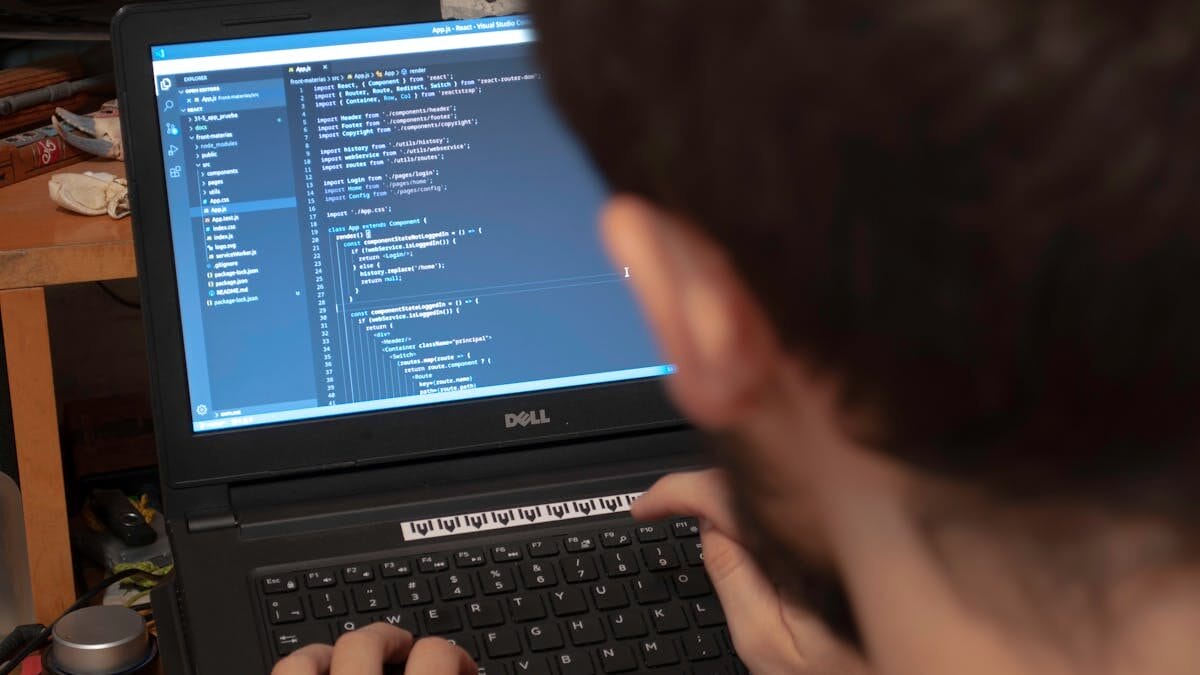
[113, 0, 742, 675]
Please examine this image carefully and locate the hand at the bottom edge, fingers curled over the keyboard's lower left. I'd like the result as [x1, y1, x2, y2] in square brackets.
[271, 623, 478, 675]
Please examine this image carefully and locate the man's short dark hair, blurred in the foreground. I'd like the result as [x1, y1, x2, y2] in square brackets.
[533, 0, 1200, 513]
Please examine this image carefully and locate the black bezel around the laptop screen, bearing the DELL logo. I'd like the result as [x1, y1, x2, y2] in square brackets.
[113, 0, 682, 488]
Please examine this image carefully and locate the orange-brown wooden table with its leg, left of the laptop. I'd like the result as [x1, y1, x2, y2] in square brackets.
[0, 160, 137, 623]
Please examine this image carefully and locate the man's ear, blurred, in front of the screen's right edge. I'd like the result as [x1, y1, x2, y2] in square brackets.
[601, 196, 781, 429]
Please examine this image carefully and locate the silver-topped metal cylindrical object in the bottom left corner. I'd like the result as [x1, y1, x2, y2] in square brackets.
[50, 607, 154, 675]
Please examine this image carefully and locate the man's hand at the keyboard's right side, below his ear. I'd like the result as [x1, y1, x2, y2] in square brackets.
[632, 470, 870, 675]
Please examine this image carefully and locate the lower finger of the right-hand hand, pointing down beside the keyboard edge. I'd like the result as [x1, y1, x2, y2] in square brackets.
[700, 525, 797, 673]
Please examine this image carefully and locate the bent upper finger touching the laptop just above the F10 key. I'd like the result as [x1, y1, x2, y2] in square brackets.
[631, 468, 737, 536]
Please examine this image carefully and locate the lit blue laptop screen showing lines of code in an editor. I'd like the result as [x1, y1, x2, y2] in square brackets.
[151, 17, 672, 432]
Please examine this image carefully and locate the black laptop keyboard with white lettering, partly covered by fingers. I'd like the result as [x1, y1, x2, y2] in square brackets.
[256, 519, 746, 675]
